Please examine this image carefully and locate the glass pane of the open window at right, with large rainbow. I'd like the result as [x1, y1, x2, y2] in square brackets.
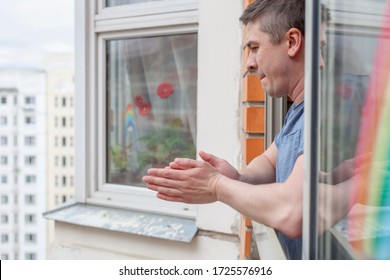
[317, 0, 390, 259]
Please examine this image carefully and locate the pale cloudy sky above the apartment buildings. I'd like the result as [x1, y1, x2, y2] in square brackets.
[0, 0, 77, 68]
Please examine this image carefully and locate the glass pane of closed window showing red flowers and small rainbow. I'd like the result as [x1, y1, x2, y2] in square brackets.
[106, 34, 197, 186]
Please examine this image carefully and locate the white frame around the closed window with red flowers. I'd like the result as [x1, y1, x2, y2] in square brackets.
[75, 0, 198, 218]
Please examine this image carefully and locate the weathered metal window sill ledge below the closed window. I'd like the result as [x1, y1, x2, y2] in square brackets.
[43, 203, 198, 243]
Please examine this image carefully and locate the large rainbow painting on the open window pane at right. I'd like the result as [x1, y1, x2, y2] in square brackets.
[348, 1, 390, 259]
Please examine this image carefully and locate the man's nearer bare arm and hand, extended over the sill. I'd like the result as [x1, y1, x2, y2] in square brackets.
[143, 151, 303, 237]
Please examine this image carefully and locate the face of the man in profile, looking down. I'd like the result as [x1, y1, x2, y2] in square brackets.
[246, 20, 288, 97]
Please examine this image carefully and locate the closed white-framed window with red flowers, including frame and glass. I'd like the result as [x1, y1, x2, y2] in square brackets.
[77, 0, 198, 217]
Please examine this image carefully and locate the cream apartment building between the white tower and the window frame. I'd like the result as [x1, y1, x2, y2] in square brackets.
[44, 53, 74, 250]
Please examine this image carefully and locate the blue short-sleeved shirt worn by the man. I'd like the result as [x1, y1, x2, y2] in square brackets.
[275, 102, 304, 259]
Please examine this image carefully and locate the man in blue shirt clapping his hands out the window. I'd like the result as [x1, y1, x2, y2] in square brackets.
[143, 0, 327, 259]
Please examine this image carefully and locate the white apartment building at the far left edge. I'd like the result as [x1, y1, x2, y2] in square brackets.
[0, 69, 47, 260]
